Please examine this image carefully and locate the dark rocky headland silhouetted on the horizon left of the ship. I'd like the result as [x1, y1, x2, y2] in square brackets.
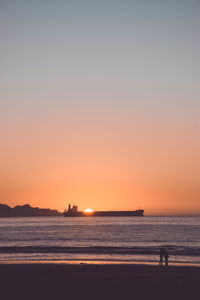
[0, 204, 63, 217]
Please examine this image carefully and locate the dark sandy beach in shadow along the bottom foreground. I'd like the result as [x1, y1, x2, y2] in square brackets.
[0, 264, 200, 300]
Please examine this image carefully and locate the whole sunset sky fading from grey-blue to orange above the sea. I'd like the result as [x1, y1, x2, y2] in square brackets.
[0, 0, 200, 215]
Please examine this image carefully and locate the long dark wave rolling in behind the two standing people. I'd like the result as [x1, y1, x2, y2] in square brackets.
[0, 244, 200, 256]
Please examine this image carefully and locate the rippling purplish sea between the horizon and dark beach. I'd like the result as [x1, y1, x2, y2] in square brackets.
[0, 216, 200, 265]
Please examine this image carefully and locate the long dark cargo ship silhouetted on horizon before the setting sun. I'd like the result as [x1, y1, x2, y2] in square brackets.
[63, 204, 144, 217]
